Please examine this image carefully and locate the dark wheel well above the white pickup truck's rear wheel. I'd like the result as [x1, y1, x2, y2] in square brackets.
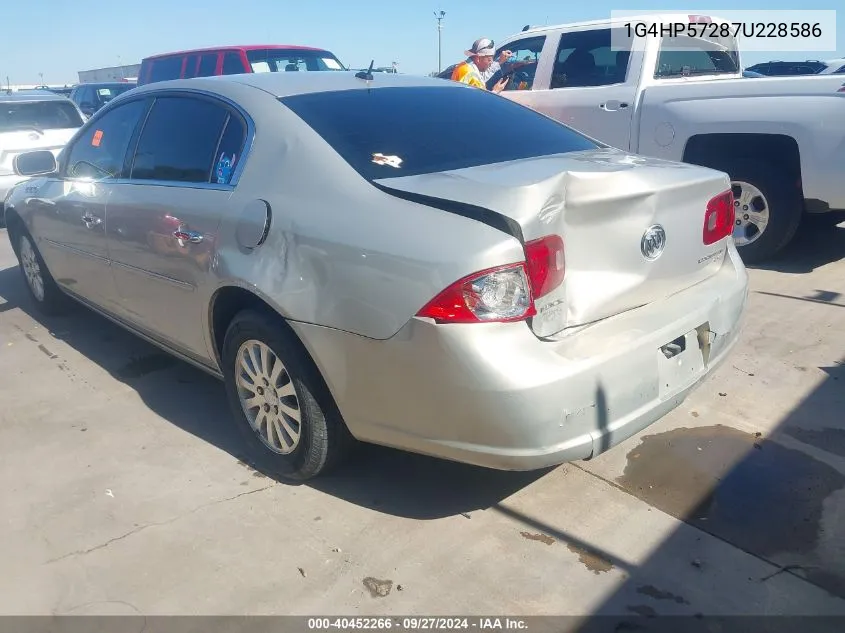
[683, 134, 803, 190]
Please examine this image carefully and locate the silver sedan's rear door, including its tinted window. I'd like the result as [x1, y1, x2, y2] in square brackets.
[108, 91, 247, 361]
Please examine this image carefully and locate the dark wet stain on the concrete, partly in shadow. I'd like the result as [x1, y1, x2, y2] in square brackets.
[617, 425, 845, 597]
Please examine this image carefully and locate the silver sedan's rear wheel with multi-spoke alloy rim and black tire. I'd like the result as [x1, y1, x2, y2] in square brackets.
[222, 310, 352, 481]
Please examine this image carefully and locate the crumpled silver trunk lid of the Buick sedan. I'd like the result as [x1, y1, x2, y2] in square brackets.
[377, 148, 731, 337]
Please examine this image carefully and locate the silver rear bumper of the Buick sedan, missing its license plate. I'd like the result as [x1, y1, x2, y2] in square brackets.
[294, 245, 748, 470]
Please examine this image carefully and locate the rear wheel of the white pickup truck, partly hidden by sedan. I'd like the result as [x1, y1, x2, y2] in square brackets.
[717, 160, 804, 264]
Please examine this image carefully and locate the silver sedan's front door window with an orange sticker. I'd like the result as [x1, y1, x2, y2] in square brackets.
[63, 100, 146, 180]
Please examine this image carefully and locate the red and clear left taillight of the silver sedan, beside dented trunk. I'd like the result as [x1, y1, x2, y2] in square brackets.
[417, 235, 565, 323]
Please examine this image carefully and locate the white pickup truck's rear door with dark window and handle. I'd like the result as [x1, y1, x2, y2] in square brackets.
[506, 27, 643, 150]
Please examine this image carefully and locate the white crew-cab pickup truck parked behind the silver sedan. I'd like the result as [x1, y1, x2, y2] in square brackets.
[491, 14, 845, 263]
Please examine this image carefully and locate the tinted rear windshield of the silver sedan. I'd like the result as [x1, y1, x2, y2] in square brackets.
[279, 86, 599, 180]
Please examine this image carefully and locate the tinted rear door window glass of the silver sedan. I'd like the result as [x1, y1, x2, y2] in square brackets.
[131, 97, 229, 183]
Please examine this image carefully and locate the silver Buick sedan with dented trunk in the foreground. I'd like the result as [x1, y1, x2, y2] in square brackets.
[5, 72, 748, 480]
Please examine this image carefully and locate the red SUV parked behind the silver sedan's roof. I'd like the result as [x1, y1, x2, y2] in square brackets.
[138, 44, 347, 86]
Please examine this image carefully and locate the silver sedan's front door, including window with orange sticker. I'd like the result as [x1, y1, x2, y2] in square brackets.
[31, 100, 146, 310]
